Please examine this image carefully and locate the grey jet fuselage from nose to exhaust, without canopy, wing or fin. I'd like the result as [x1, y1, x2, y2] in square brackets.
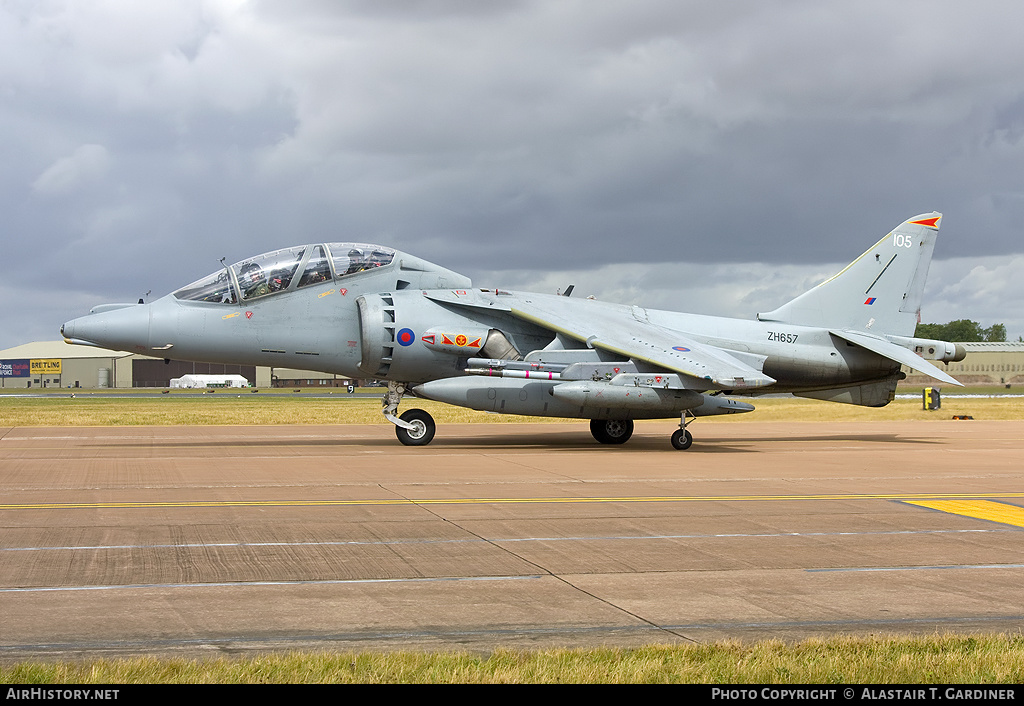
[63, 272, 899, 393]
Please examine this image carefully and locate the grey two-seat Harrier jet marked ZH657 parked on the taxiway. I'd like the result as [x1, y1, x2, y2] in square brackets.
[61, 213, 966, 449]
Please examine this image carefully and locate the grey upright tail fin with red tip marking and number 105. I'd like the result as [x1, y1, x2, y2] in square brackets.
[758, 211, 942, 336]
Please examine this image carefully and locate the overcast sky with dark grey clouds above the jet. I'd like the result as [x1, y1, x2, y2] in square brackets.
[0, 0, 1024, 349]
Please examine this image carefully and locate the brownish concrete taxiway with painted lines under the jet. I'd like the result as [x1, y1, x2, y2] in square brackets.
[0, 420, 1024, 661]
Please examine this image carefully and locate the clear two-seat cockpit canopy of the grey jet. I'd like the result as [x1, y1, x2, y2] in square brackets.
[173, 243, 395, 304]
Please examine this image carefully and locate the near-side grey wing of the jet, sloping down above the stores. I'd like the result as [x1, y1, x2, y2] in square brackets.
[510, 297, 775, 389]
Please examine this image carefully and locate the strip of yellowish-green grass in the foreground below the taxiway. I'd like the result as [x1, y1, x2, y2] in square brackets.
[0, 634, 1024, 683]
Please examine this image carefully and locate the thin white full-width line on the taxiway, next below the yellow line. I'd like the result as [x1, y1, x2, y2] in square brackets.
[6, 529, 1020, 551]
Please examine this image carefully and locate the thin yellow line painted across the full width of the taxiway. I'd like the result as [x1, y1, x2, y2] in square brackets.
[0, 492, 1024, 510]
